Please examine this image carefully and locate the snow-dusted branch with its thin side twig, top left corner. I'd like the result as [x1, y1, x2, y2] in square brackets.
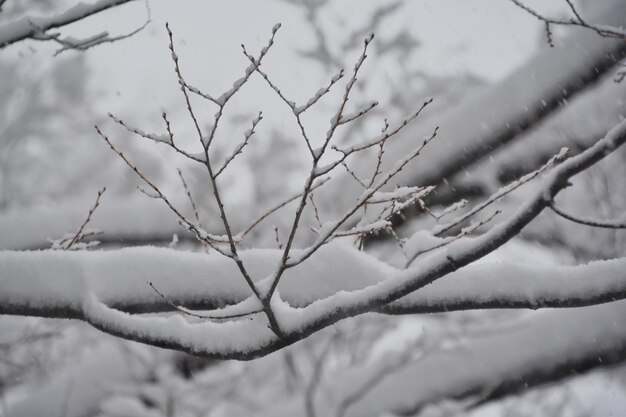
[0, 0, 143, 53]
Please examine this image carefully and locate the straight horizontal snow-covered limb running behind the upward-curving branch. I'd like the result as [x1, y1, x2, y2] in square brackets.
[0, 244, 626, 356]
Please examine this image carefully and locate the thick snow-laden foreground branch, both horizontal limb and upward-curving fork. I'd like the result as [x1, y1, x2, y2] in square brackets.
[0, 117, 626, 359]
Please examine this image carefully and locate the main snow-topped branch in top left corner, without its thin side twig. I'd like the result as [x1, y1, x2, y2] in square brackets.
[0, 0, 134, 48]
